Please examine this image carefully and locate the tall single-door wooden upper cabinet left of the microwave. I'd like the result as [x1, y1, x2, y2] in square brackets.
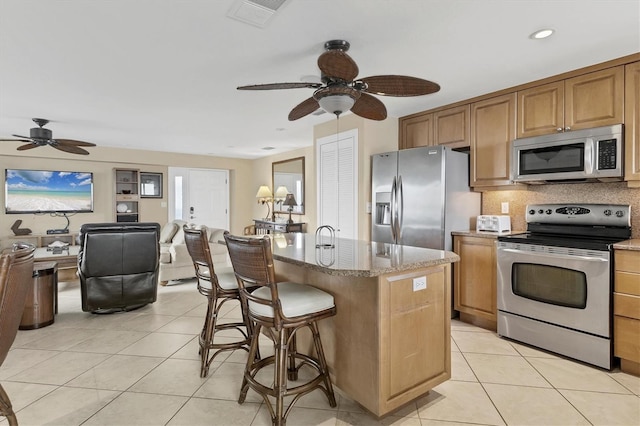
[471, 93, 516, 188]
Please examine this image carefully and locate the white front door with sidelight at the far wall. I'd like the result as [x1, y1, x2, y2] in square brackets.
[169, 167, 230, 229]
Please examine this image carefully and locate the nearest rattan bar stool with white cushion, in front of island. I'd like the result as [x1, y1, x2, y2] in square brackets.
[224, 234, 336, 425]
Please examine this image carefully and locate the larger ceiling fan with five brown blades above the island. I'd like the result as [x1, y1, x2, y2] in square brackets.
[238, 40, 440, 121]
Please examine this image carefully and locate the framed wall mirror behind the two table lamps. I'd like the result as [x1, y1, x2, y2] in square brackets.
[271, 157, 305, 214]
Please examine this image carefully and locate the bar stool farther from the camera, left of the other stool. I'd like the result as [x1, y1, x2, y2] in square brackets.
[183, 225, 251, 377]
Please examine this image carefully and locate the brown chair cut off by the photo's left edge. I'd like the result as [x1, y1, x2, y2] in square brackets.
[0, 243, 35, 426]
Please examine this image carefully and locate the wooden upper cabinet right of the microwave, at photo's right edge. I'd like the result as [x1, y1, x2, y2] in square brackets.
[624, 62, 640, 183]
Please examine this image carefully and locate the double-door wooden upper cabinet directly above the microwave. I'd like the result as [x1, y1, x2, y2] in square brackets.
[517, 66, 624, 138]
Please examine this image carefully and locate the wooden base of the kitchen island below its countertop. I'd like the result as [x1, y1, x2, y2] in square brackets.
[274, 260, 451, 417]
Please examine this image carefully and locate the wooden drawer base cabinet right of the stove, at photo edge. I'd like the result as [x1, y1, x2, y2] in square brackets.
[613, 250, 640, 376]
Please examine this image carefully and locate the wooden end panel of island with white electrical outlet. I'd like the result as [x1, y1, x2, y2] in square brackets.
[380, 265, 451, 411]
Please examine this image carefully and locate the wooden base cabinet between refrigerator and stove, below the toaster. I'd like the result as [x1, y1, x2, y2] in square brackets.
[453, 235, 498, 331]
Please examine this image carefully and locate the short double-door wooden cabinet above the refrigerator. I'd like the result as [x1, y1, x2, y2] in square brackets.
[399, 105, 470, 149]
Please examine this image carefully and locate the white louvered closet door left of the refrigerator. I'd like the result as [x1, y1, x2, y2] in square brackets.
[316, 129, 358, 239]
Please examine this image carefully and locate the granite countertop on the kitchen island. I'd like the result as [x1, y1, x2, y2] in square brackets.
[272, 233, 460, 277]
